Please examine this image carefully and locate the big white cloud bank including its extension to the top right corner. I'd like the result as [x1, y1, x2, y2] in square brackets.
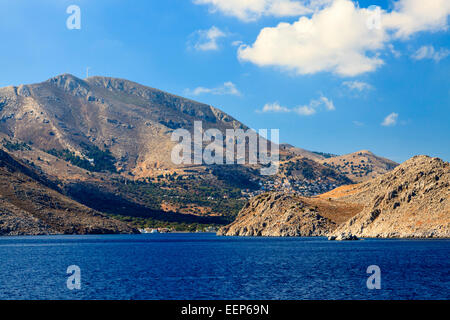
[238, 0, 450, 76]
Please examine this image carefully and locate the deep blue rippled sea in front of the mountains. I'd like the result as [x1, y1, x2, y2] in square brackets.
[0, 234, 450, 300]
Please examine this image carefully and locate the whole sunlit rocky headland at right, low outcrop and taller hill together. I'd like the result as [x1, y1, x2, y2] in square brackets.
[218, 156, 450, 239]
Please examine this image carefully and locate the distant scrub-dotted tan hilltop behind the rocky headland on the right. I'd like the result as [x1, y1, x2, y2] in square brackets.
[319, 150, 398, 182]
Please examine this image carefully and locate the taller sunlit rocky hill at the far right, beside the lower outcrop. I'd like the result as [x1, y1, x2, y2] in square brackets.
[323, 156, 450, 238]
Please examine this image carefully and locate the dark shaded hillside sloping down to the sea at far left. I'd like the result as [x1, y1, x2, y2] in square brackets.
[0, 149, 137, 235]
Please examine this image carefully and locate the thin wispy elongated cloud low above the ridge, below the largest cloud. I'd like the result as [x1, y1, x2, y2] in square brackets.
[257, 96, 336, 116]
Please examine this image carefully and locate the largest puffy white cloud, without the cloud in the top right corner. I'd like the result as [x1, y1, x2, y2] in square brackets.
[238, 0, 387, 76]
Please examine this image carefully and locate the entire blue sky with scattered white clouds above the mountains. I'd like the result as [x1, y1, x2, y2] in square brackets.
[0, 0, 450, 162]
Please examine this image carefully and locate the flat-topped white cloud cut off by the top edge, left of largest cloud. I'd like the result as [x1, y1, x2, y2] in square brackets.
[193, 0, 333, 22]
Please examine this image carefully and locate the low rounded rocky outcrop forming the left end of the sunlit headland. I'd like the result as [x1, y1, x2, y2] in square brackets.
[218, 193, 361, 237]
